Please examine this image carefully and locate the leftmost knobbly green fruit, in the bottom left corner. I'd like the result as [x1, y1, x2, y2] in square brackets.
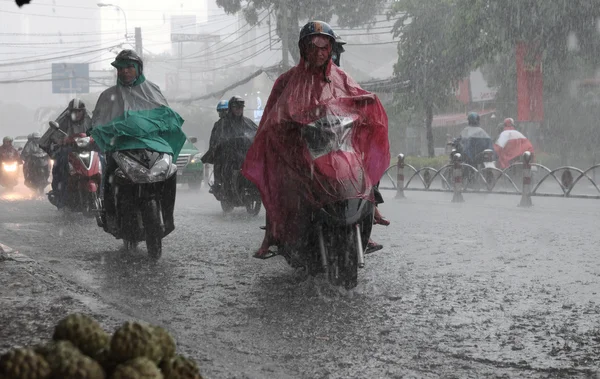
[0, 349, 51, 379]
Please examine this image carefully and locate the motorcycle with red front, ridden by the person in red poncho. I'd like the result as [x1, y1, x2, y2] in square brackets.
[268, 115, 375, 289]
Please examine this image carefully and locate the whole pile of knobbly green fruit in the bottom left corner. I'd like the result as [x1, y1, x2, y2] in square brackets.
[0, 313, 202, 379]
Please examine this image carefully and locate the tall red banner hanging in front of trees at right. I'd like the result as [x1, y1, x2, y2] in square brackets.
[516, 42, 544, 122]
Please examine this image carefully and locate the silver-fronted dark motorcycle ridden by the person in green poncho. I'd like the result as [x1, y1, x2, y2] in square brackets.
[99, 149, 177, 259]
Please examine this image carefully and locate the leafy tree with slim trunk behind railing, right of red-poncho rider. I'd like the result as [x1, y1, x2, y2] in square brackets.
[391, 0, 473, 157]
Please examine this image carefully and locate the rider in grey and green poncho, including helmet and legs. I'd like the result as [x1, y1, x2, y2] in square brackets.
[88, 49, 187, 235]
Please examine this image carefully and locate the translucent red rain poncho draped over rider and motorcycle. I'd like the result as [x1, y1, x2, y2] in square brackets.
[242, 60, 390, 242]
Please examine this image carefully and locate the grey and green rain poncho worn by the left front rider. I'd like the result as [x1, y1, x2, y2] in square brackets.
[90, 77, 186, 160]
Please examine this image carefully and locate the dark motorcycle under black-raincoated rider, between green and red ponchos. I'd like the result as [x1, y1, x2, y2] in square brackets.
[210, 134, 262, 216]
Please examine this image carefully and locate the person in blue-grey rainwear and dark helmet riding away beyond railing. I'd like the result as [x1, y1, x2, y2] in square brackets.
[457, 112, 493, 167]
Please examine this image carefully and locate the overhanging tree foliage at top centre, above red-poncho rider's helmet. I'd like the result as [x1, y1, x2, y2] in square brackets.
[217, 0, 387, 62]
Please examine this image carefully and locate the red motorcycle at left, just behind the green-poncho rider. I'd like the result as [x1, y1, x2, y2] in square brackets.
[48, 121, 102, 219]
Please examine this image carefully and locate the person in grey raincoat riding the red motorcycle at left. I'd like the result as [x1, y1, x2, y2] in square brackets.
[48, 98, 91, 209]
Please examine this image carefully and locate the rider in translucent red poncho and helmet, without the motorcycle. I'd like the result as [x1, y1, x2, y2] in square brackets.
[242, 21, 390, 257]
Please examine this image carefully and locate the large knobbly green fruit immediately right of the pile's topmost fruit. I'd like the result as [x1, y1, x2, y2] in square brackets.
[110, 321, 163, 364]
